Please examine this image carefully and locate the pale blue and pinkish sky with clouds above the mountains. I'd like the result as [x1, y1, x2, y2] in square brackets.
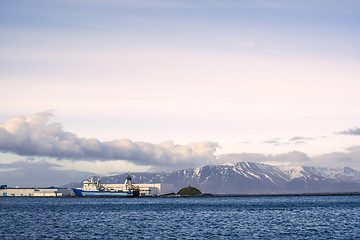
[0, 0, 360, 186]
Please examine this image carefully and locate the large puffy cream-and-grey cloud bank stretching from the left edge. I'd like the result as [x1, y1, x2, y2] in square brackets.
[0, 112, 218, 166]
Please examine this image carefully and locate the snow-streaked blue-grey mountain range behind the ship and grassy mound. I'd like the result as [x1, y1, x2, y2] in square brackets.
[64, 162, 360, 194]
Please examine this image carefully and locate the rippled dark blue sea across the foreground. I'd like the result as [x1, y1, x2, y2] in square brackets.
[0, 196, 360, 239]
